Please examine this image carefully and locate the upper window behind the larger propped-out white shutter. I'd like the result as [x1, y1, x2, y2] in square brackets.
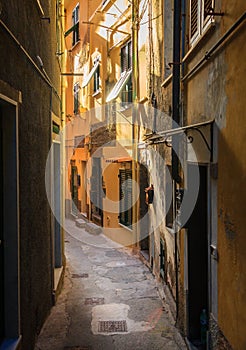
[120, 41, 132, 103]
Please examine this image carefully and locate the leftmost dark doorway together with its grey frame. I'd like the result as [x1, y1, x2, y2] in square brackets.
[0, 93, 21, 349]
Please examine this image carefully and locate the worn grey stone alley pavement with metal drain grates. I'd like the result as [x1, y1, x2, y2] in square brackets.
[35, 220, 186, 350]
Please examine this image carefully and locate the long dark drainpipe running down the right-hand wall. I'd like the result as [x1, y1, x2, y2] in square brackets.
[172, 0, 181, 322]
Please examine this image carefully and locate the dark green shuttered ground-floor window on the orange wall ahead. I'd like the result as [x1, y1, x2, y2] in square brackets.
[119, 169, 132, 227]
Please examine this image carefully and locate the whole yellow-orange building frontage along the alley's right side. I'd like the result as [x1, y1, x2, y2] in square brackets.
[65, 0, 246, 349]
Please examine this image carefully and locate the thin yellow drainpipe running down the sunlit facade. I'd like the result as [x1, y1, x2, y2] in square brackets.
[132, 0, 139, 246]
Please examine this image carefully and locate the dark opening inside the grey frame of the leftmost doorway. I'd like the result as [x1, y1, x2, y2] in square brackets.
[0, 99, 20, 342]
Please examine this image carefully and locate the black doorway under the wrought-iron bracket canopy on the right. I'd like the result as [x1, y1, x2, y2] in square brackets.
[187, 164, 208, 349]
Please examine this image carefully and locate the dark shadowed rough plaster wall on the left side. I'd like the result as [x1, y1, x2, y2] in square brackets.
[0, 0, 60, 350]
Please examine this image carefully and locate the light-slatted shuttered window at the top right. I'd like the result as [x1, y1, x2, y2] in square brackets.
[190, 0, 214, 45]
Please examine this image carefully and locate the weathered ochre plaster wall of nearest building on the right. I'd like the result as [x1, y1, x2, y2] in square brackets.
[184, 1, 246, 349]
